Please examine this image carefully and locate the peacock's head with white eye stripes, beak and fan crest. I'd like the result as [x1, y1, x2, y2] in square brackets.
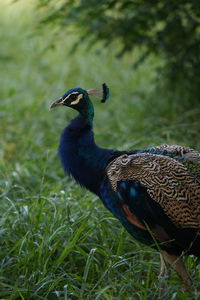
[50, 83, 109, 116]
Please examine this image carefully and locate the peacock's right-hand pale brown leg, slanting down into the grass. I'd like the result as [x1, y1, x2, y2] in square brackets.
[161, 250, 192, 290]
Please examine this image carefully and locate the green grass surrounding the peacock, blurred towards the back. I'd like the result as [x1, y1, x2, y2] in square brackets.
[0, 1, 200, 300]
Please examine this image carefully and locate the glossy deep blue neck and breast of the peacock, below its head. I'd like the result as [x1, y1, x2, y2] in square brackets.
[59, 114, 118, 195]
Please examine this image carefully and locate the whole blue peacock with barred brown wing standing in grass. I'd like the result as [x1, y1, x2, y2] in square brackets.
[51, 83, 200, 287]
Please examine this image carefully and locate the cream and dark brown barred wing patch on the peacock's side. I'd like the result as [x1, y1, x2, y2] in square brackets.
[107, 153, 200, 228]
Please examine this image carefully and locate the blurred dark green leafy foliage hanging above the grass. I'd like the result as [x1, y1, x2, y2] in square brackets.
[39, 0, 200, 101]
